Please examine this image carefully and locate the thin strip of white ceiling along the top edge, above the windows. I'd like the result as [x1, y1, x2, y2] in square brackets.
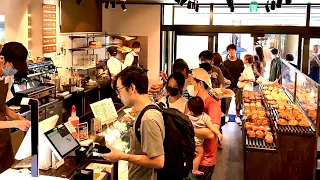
[127, 0, 320, 4]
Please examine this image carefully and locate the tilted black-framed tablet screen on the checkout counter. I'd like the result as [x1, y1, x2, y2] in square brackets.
[44, 124, 80, 161]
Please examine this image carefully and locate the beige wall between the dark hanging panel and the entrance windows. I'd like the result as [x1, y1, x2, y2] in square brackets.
[102, 5, 160, 79]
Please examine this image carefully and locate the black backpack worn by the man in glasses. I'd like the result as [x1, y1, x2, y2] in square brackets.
[135, 104, 196, 180]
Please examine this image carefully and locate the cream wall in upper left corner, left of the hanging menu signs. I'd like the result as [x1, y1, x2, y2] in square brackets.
[0, 0, 28, 47]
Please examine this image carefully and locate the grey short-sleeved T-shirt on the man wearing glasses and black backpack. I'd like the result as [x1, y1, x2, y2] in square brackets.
[128, 109, 165, 180]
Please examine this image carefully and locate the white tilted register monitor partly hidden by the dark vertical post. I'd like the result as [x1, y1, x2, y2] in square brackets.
[15, 115, 59, 170]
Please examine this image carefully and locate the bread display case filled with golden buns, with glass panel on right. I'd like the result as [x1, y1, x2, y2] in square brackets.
[243, 62, 319, 180]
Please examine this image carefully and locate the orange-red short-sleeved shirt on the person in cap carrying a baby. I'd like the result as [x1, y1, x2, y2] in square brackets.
[200, 96, 221, 166]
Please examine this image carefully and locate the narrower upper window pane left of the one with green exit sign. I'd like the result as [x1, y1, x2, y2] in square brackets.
[173, 6, 210, 25]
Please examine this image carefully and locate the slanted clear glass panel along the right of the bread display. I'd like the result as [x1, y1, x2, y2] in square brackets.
[282, 62, 320, 127]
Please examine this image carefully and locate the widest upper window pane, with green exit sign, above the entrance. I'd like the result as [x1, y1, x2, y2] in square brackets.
[213, 5, 306, 26]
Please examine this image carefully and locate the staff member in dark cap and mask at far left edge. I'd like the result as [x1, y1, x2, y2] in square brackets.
[0, 42, 31, 173]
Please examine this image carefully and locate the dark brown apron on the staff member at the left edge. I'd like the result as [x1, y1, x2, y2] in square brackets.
[0, 79, 14, 173]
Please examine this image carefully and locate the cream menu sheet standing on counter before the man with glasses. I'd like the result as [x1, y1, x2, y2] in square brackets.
[90, 98, 118, 125]
